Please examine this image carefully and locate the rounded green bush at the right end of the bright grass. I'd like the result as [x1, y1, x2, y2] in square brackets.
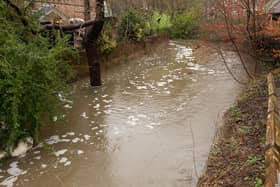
[170, 12, 199, 39]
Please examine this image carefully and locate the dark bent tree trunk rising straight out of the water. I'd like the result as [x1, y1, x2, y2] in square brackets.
[84, 0, 104, 86]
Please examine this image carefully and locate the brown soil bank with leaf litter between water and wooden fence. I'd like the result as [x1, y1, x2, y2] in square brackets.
[198, 80, 268, 187]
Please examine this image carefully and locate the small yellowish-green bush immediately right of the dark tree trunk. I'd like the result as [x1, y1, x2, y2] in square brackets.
[98, 23, 117, 55]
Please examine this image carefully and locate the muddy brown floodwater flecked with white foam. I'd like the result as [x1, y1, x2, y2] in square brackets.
[0, 41, 248, 187]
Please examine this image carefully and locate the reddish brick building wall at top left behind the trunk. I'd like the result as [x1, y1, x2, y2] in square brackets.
[34, 0, 96, 19]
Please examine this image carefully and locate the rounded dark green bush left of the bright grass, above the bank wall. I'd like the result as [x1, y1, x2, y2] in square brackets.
[119, 11, 147, 42]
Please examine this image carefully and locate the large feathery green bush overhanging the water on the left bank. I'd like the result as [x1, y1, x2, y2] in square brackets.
[0, 1, 75, 152]
